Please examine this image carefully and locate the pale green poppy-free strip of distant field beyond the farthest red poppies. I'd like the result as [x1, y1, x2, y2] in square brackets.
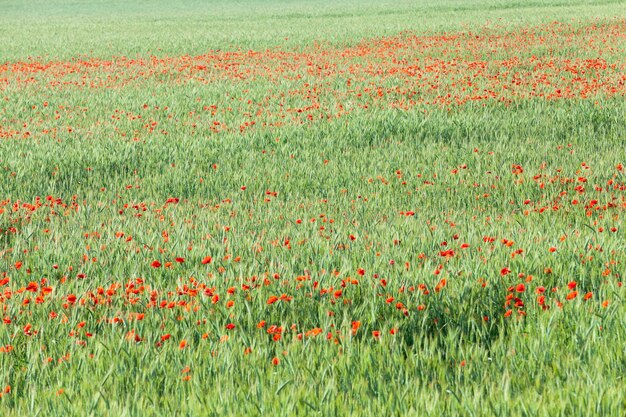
[0, 0, 626, 63]
